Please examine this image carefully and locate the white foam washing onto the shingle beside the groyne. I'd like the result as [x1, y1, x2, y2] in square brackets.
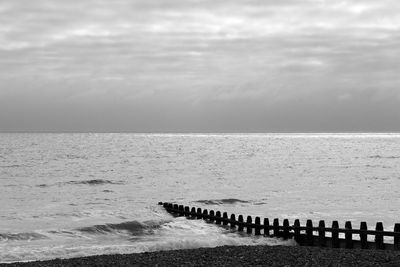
[0, 217, 296, 262]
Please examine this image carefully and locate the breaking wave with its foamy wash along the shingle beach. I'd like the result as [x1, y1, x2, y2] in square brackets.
[0, 217, 296, 262]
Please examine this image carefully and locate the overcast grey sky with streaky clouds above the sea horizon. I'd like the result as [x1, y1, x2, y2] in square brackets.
[0, 0, 400, 132]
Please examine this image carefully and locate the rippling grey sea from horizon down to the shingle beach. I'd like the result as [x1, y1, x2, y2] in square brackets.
[0, 133, 400, 263]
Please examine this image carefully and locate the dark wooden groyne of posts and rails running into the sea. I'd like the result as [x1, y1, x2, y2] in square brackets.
[158, 202, 400, 250]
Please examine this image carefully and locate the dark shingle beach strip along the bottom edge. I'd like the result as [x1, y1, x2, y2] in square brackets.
[0, 246, 400, 267]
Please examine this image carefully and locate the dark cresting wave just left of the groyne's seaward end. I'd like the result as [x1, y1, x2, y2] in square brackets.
[77, 221, 167, 236]
